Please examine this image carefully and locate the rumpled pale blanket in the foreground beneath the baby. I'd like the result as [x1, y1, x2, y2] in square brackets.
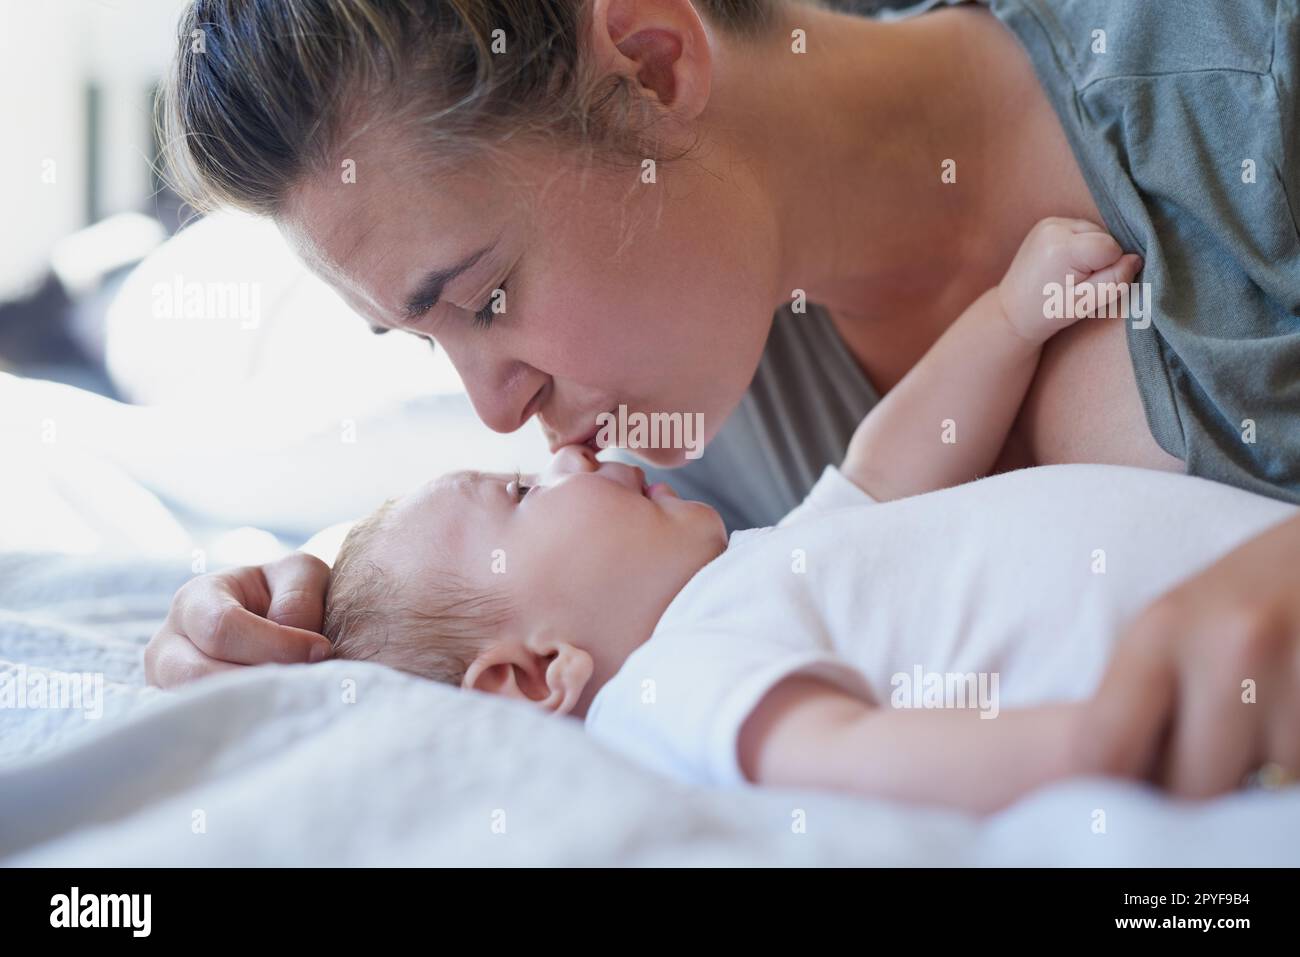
[0, 554, 1300, 866]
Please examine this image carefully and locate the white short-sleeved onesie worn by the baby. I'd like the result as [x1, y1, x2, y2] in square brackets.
[586, 465, 1296, 784]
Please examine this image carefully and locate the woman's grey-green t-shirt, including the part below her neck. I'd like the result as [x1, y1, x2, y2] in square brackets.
[634, 0, 1300, 529]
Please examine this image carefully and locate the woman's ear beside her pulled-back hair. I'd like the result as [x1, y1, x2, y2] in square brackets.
[588, 0, 712, 121]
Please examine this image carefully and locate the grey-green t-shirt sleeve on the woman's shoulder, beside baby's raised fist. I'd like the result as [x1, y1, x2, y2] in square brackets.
[989, 0, 1300, 503]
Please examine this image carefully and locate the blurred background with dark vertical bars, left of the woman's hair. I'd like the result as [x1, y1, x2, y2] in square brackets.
[0, 0, 187, 394]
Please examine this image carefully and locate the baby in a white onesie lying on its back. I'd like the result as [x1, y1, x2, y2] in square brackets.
[325, 220, 1291, 811]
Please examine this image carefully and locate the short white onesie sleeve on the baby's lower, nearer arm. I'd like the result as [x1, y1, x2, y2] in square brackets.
[586, 628, 872, 787]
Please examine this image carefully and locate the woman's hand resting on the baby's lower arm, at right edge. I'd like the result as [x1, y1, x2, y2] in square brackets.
[1084, 518, 1300, 797]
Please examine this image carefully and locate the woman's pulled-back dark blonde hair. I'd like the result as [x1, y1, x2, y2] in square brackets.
[157, 0, 807, 216]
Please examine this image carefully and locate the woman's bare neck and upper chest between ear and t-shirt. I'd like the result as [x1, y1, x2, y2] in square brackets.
[728, 7, 1096, 351]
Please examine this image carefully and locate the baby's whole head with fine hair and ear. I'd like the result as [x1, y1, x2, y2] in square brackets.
[325, 446, 727, 716]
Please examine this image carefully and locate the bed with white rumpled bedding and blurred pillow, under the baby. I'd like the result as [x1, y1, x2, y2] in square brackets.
[0, 217, 1300, 866]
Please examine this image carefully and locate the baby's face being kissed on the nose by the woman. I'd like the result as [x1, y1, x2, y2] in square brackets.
[382, 446, 727, 683]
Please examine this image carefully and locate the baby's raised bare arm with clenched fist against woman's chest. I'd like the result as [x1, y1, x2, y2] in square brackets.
[841, 220, 1141, 501]
